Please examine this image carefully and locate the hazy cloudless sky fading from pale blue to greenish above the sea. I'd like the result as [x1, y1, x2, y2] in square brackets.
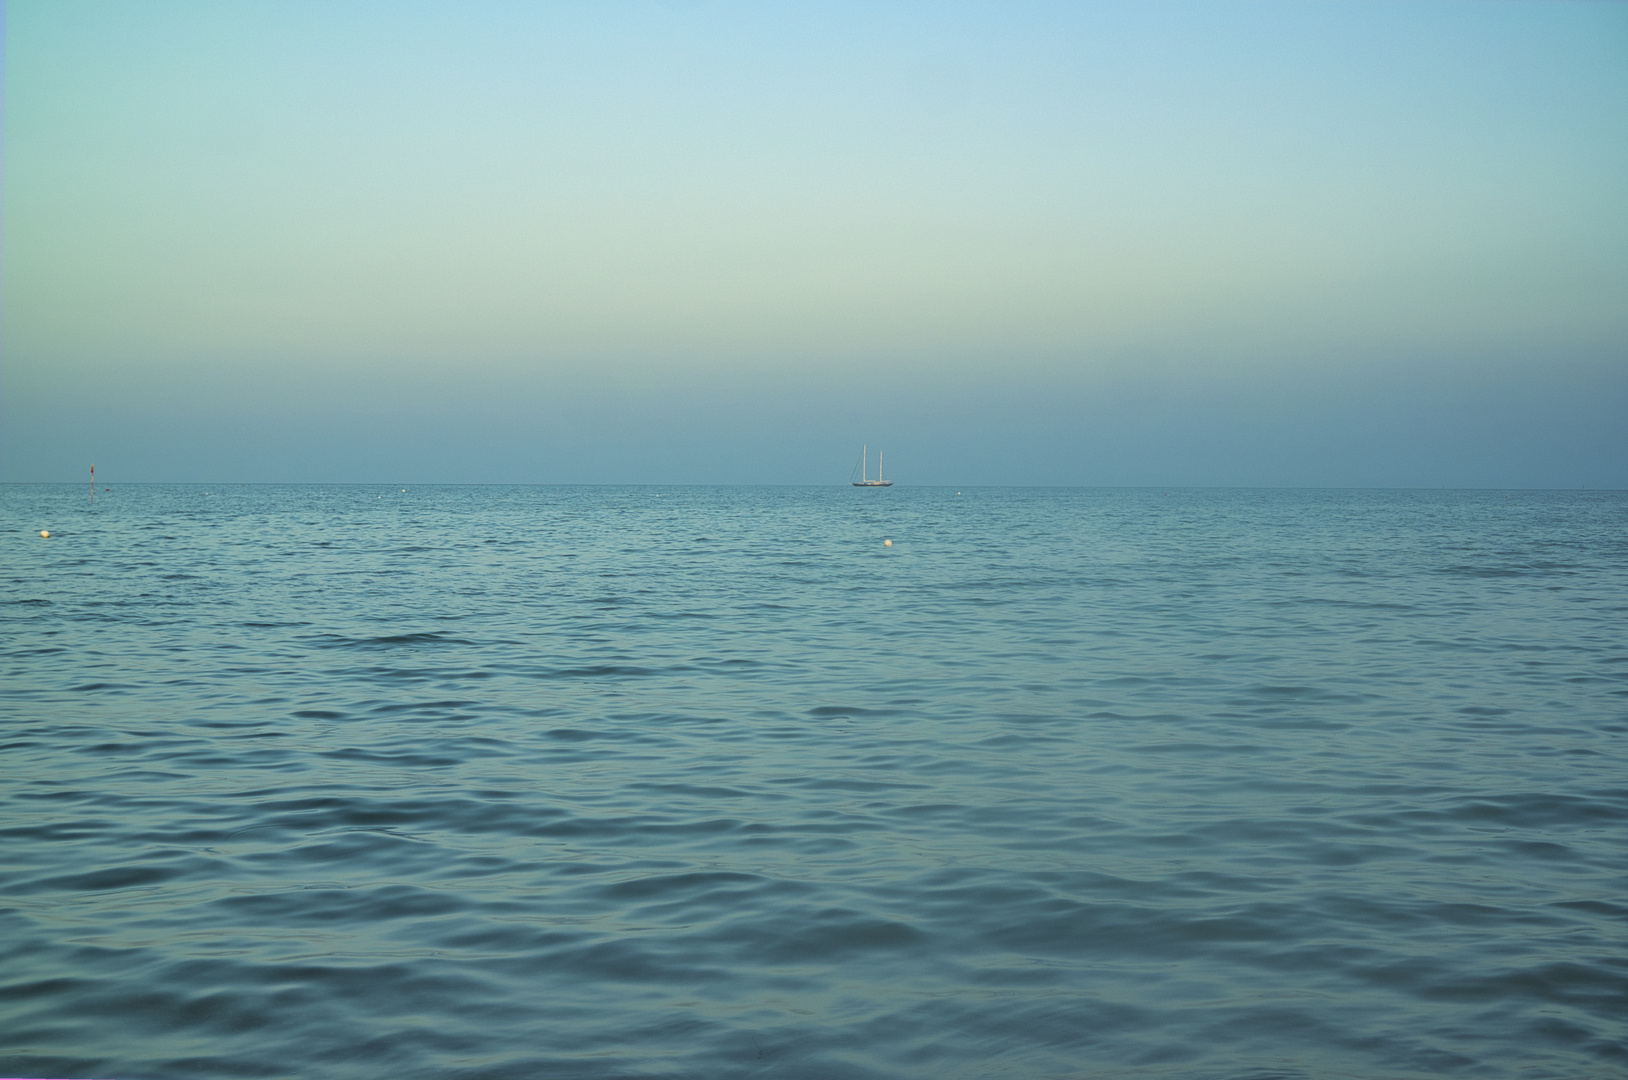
[0, 0, 1628, 489]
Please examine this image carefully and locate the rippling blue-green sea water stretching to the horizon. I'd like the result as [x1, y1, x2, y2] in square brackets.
[0, 485, 1628, 1080]
